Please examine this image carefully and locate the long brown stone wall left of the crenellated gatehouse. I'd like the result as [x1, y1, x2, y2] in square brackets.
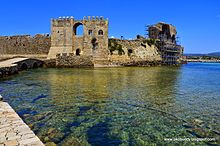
[0, 34, 51, 56]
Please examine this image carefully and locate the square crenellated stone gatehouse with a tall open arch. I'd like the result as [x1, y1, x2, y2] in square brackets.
[48, 16, 109, 60]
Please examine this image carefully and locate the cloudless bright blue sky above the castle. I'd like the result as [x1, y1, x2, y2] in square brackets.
[0, 0, 220, 53]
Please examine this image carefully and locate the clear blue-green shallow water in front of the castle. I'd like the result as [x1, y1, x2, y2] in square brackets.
[0, 63, 220, 146]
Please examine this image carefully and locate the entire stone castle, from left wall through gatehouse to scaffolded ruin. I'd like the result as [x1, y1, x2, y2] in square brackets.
[0, 17, 183, 67]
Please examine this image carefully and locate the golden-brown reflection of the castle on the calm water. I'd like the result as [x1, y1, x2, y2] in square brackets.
[46, 67, 179, 111]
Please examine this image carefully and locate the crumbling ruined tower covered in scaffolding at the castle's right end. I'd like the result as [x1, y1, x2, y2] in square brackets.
[148, 22, 183, 64]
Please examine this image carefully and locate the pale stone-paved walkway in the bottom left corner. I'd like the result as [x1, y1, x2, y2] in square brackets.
[0, 101, 44, 146]
